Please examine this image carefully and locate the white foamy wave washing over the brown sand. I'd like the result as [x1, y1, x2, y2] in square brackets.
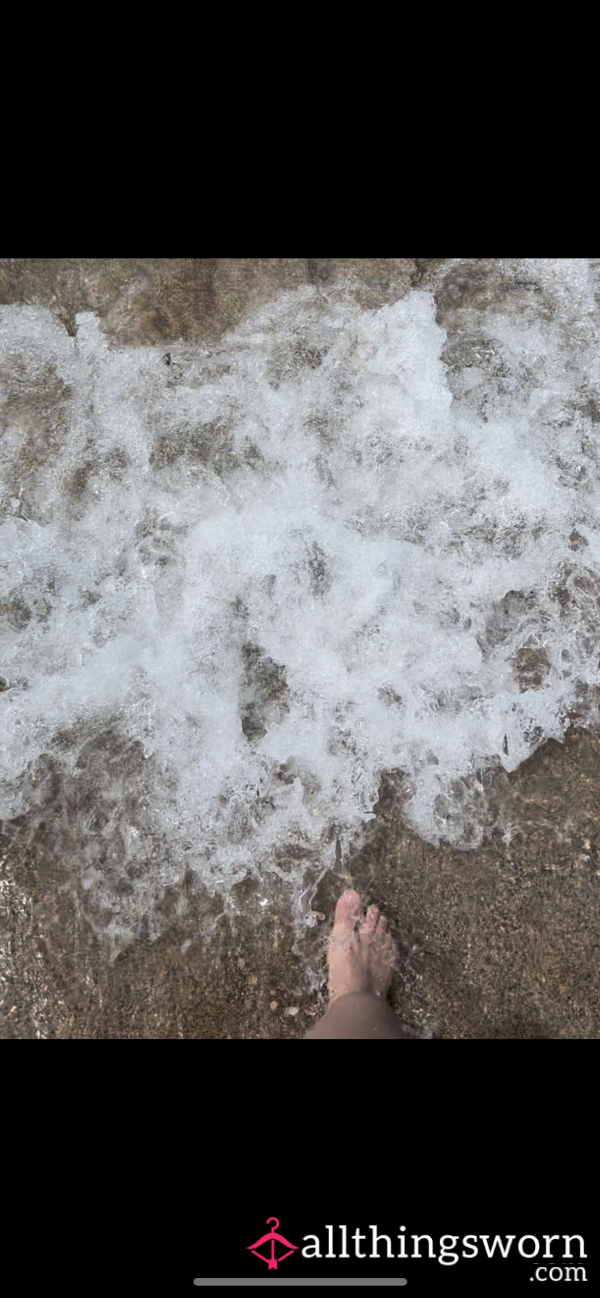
[0, 261, 600, 934]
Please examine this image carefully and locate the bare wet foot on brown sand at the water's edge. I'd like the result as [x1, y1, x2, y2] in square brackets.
[329, 888, 400, 1005]
